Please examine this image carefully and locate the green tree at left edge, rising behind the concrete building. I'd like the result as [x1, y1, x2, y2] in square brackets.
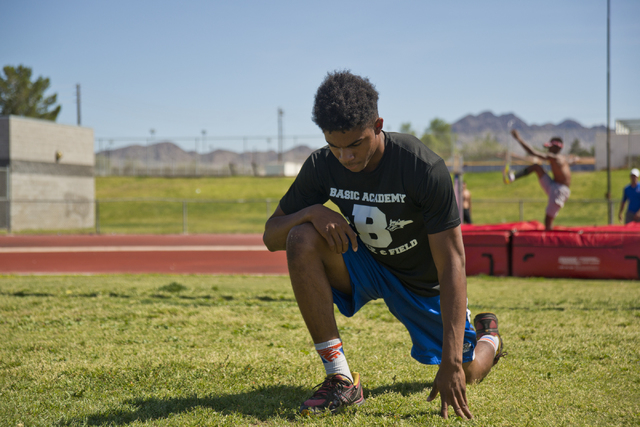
[0, 65, 62, 121]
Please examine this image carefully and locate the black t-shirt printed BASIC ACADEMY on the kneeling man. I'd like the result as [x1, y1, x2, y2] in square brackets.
[280, 133, 460, 296]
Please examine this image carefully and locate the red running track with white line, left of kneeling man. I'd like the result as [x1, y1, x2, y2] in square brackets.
[0, 234, 288, 274]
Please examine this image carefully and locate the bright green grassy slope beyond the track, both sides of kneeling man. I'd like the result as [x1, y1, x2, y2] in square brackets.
[89, 170, 629, 233]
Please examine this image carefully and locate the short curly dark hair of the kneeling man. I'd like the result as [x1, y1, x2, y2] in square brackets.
[312, 70, 378, 132]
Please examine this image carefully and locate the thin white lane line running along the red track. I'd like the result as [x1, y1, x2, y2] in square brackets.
[0, 245, 267, 254]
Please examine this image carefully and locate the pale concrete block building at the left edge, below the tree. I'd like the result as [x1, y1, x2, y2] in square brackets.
[0, 116, 95, 231]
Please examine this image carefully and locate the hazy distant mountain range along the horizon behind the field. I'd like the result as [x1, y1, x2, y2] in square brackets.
[96, 111, 606, 167]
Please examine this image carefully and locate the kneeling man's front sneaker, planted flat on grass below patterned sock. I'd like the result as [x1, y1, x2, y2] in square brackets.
[300, 372, 364, 415]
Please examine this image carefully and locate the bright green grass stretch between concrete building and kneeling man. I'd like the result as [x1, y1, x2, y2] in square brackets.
[96, 177, 293, 233]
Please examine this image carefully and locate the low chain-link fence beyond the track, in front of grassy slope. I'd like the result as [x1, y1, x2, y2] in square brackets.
[0, 197, 620, 234]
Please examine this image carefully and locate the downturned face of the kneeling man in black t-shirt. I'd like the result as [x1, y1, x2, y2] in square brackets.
[324, 119, 384, 172]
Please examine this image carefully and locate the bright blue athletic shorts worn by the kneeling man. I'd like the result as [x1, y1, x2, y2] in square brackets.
[333, 241, 476, 365]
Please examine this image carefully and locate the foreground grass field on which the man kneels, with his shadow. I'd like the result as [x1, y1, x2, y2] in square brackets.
[0, 275, 640, 427]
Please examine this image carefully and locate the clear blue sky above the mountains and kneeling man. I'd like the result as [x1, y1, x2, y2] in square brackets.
[0, 0, 640, 151]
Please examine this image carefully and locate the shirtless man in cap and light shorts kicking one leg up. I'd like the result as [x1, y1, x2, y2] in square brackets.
[503, 129, 571, 230]
